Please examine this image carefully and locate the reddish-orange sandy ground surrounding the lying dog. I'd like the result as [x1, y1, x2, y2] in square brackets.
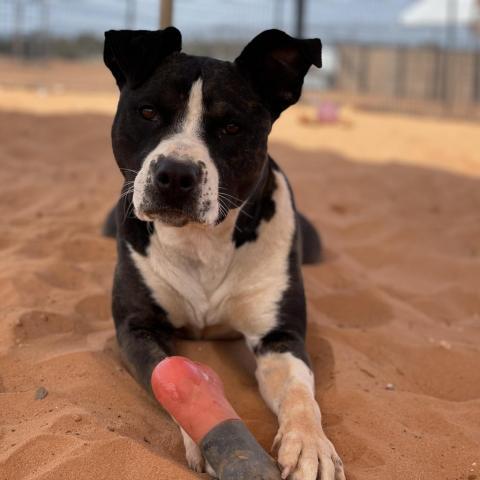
[0, 61, 480, 480]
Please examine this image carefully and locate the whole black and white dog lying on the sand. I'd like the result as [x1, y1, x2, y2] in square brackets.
[104, 27, 345, 480]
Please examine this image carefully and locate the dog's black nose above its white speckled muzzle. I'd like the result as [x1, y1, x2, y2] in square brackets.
[155, 158, 200, 194]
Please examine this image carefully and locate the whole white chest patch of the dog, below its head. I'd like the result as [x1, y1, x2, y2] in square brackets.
[131, 174, 295, 337]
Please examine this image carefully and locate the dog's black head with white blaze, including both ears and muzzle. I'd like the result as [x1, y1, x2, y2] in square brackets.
[104, 27, 322, 226]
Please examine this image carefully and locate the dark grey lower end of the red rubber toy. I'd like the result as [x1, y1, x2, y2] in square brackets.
[200, 420, 281, 480]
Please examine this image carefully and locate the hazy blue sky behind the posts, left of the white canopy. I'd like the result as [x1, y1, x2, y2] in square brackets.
[0, 0, 412, 35]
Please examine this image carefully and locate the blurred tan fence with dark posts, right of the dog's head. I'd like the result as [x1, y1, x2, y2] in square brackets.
[334, 43, 480, 115]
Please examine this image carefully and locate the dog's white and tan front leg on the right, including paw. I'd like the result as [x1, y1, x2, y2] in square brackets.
[251, 334, 345, 480]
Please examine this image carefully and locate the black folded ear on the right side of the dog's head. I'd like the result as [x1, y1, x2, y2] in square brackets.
[235, 30, 322, 120]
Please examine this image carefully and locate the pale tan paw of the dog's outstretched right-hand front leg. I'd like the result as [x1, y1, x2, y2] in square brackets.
[273, 421, 345, 480]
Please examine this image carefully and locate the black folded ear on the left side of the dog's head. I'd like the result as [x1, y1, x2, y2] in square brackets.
[103, 27, 182, 89]
